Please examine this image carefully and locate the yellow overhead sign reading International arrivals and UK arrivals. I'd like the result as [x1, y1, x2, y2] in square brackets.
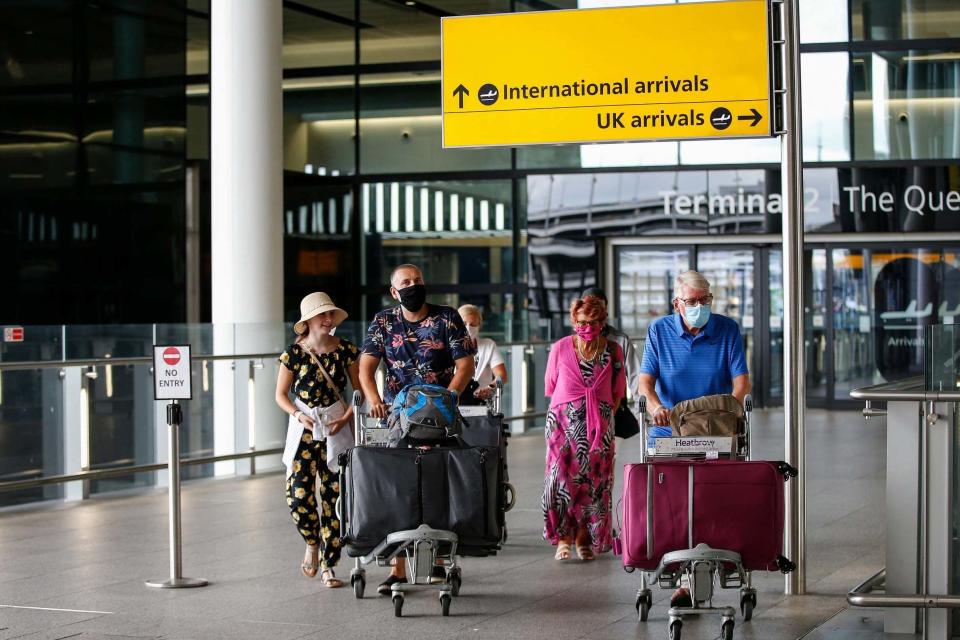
[441, 0, 773, 148]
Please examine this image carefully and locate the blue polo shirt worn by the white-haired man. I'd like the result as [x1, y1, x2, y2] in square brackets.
[640, 313, 748, 409]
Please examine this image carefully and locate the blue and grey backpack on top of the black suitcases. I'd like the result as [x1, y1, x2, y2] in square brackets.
[387, 384, 463, 447]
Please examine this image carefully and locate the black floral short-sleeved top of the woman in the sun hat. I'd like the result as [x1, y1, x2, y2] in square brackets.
[279, 338, 360, 407]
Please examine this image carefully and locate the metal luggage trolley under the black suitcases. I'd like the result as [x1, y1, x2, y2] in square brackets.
[337, 391, 462, 617]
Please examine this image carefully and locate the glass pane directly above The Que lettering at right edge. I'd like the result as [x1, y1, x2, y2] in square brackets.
[853, 51, 960, 160]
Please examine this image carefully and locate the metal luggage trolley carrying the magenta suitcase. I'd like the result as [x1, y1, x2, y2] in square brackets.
[627, 395, 757, 640]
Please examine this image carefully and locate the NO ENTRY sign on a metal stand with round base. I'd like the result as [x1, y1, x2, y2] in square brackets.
[146, 345, 207, 589]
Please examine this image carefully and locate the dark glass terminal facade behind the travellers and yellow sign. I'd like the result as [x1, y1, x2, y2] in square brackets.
[0, 0, 960, 408]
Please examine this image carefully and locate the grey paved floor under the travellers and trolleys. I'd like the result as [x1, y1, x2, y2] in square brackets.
[0, 410, 886, 640]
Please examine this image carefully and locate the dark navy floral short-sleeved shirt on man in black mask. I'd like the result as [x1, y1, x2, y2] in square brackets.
[361, 304, 476, 404]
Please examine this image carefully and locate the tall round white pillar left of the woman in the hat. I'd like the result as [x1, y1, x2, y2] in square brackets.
[210, 0, 283, 475]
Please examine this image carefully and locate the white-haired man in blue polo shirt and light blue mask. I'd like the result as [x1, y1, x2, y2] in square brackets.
[639, 271, 750, 437]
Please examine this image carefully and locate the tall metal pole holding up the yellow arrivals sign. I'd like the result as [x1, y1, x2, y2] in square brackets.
[780, 0, 807, 595]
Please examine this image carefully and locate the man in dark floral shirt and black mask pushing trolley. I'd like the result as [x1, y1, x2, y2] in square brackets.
[360, 264, 476, 595]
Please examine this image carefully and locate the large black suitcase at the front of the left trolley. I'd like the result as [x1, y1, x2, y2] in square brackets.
[340, 447, 505, 557]
